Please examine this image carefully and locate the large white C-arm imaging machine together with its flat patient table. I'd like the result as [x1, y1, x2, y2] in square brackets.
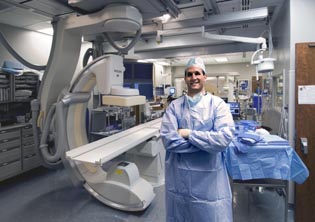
[32, 4, 163, 211]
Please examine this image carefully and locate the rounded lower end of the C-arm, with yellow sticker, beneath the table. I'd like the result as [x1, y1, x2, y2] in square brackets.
[84, 161, 155, 211]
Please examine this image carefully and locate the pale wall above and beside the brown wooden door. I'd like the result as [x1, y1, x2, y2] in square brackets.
[272, 0, 315, 203]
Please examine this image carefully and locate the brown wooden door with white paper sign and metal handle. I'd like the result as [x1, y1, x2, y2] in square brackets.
[295, 42, 315, 222]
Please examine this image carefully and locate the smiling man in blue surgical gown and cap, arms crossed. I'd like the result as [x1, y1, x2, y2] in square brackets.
[160, 58, 234, 222]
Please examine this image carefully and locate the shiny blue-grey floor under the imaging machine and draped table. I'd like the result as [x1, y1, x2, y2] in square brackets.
[0, 167, 294, 222]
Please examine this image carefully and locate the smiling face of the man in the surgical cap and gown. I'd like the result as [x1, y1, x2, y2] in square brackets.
[185, 66, 207, 94]
